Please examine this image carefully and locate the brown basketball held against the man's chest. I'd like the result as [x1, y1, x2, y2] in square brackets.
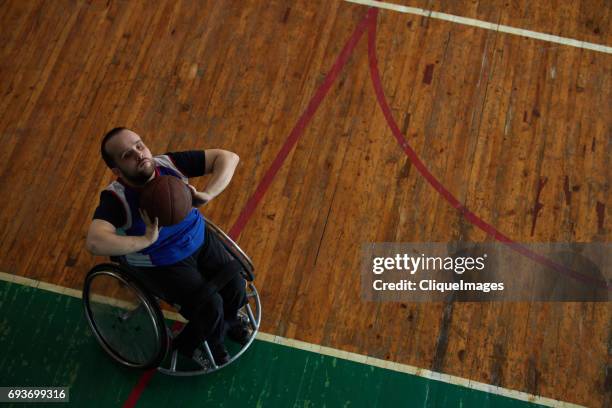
[139, 176, 192, 226]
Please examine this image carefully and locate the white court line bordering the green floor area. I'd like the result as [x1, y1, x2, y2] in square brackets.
[0, 272, 582, 408]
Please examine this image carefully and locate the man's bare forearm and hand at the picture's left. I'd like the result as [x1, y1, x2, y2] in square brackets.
[85, 213, 159, 256]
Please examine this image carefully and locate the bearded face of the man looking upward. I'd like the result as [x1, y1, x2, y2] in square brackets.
[106, 130, 155, 185]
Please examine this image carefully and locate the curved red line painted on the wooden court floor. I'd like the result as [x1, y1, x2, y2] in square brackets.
[368, 8, 612, 291]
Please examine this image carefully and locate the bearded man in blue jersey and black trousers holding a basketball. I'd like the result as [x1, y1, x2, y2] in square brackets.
[86, 127, 249, 365]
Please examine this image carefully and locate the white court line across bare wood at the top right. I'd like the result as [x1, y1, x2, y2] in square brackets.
[344, 0, 612, 54]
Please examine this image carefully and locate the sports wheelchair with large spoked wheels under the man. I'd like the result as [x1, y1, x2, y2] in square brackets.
[83, 219, 261, 376]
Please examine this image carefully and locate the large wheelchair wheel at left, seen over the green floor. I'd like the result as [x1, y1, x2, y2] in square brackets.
[83, 264, 170, 368]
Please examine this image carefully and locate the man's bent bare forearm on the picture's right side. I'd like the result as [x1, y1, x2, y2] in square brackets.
[190, 149, 240, 206]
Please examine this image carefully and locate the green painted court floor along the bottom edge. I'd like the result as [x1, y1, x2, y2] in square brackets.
[0, 281, 535, 408]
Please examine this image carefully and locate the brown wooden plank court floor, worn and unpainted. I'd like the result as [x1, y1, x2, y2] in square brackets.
[0, 0, 612, 406]
